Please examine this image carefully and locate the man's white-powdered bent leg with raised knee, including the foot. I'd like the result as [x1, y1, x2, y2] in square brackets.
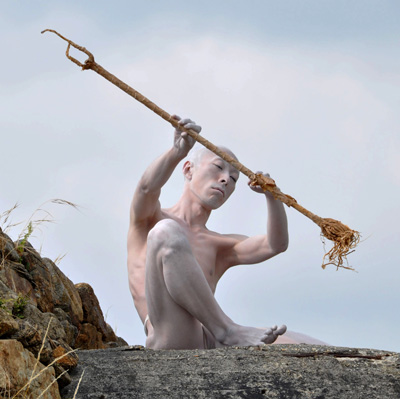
[146, 219, 286, 349]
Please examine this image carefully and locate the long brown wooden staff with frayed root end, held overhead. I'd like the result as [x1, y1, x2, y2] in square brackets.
[42, 29, 360, 270]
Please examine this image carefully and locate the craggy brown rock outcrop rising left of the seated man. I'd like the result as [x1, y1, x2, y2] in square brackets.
[0, 229, 127, 397]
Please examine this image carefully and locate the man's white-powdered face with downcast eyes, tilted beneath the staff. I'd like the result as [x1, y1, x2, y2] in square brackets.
[190, 152, 239, 210]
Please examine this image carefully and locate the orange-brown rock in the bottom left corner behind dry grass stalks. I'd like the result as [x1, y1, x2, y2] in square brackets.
[0, 340, 60, 399]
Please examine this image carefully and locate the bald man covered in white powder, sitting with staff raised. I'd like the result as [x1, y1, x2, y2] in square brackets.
[128, 116, 288, 349]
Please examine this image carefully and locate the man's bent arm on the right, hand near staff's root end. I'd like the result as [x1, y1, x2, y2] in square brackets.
[228, 174, 289, 267]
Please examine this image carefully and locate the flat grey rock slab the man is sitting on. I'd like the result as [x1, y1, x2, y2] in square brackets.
[61, 345, 400, 399]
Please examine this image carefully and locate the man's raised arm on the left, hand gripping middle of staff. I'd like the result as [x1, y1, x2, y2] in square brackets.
[131, 115, 201, 225]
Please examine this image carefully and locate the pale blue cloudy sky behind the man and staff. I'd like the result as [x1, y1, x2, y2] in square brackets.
[0, 0, 400, 352]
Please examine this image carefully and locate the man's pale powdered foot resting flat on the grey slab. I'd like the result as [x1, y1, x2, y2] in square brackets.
[220, 324, 287, 346]
